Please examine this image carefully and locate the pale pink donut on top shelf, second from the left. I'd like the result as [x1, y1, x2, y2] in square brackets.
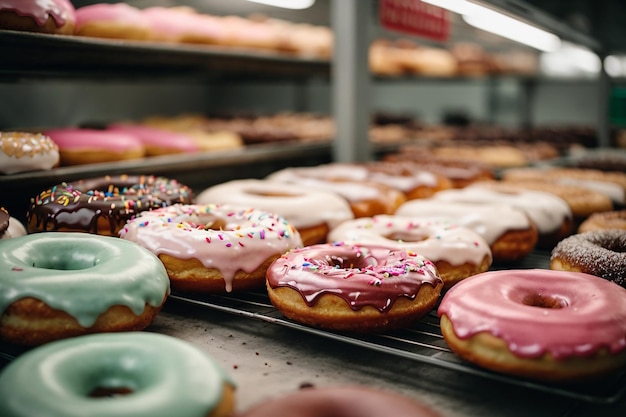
[75, 3, 152, 40]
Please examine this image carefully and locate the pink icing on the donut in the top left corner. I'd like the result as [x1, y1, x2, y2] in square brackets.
[0, 0, 76, 27]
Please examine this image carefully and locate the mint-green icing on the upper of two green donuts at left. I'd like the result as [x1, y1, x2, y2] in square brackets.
[0, 232, 170, 327]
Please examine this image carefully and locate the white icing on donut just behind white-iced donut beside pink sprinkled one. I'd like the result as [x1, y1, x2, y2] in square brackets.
[396, 199, 531, 245]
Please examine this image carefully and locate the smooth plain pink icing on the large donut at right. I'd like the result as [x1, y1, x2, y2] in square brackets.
[438, 269, 626, 359]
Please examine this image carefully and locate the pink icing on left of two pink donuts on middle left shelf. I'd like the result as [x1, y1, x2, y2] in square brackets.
[45, 128, 143, 152]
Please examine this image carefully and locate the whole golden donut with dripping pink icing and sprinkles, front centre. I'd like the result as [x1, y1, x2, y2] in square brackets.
[267, 243, 443, 333]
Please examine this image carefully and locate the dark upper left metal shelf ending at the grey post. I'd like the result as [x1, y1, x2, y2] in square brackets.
[0, 30, 330, 80]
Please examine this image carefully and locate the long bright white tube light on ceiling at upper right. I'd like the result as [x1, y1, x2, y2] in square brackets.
[422, 0, 561, 52]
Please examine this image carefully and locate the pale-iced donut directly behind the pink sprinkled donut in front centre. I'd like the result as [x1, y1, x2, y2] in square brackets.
[328, 215, 492, 290]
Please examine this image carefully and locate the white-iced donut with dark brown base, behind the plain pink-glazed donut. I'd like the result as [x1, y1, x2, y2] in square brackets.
[433, 182, 574, 248]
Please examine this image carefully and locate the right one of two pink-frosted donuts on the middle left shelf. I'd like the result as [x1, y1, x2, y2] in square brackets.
[106, 124, 200, 156]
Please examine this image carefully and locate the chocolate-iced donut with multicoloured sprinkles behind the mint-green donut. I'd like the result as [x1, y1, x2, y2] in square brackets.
[27, 175, 192, 236]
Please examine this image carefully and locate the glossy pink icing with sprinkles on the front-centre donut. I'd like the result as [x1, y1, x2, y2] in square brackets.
[267, 244, 442, 312]
